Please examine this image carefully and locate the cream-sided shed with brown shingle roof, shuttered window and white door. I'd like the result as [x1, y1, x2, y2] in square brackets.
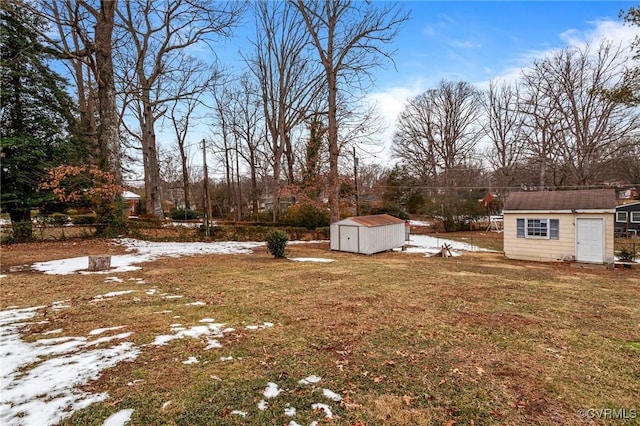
[503, 189, 616, 264]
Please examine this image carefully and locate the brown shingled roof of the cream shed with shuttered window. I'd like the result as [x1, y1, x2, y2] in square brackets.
[504, 189, 616, 210]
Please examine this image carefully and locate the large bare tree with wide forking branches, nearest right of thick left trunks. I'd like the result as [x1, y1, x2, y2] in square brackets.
[116, 0, 243, 217]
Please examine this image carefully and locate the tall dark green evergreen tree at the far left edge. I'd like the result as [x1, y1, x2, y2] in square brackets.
[0, 1, 78, 241]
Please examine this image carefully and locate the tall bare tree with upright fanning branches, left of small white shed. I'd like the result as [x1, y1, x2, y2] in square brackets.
[246, 2, 321, 221]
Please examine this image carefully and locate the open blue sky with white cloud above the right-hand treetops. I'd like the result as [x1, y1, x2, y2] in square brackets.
[356, 1, 640, 162]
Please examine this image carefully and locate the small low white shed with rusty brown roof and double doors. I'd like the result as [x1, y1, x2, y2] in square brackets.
[331, 214, 405, 254]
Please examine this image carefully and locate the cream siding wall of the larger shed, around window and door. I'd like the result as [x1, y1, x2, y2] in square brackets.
[504, 212, 614, 263]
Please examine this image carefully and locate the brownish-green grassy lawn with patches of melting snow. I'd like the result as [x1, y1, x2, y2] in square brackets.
[0, 235, 640, 425]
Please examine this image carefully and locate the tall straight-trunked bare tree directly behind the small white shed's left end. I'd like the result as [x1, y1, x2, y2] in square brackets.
[295, 0, 409, 222]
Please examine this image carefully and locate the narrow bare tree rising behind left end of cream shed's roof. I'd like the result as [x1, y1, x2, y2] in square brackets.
[484, 81, 525, 194]
